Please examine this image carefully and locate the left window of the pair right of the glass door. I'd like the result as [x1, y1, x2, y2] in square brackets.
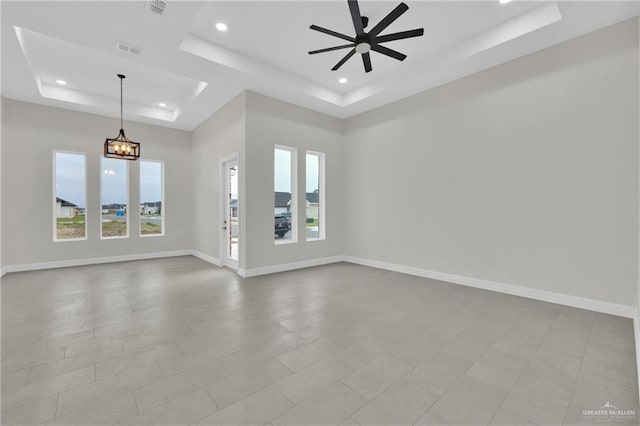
[273, 145, 297, 244]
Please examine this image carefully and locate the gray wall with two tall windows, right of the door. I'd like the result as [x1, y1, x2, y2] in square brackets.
[243, 92, 346, 268]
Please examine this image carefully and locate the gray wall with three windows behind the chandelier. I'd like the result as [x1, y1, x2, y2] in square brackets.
[2, 99, 192, 266]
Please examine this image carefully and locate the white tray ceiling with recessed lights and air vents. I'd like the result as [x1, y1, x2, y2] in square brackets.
[1, 0, 640, 130]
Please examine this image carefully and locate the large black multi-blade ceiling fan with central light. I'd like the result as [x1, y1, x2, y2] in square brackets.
[309, 0, 424, 72]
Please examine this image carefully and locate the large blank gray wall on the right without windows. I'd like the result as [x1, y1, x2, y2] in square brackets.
[344, 19, 638, 305]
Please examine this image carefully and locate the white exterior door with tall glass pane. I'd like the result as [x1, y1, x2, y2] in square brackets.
[221, 159, 240, 270]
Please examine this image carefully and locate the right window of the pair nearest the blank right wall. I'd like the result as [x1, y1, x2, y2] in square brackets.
[305, 151, 325, 241]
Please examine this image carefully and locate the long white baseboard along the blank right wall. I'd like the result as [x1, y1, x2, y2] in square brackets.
[344, 256, 637, 318]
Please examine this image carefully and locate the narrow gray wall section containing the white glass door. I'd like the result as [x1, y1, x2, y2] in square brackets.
[191, 93, 246, 268]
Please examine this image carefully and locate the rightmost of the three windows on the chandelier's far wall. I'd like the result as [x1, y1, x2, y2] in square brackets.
[140, 161, 164, 236]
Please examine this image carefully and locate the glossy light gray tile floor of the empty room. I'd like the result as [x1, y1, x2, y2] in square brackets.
[2, 257, 638, 425]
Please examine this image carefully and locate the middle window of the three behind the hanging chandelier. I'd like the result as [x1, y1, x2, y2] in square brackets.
[100, 158, 129, 238]
